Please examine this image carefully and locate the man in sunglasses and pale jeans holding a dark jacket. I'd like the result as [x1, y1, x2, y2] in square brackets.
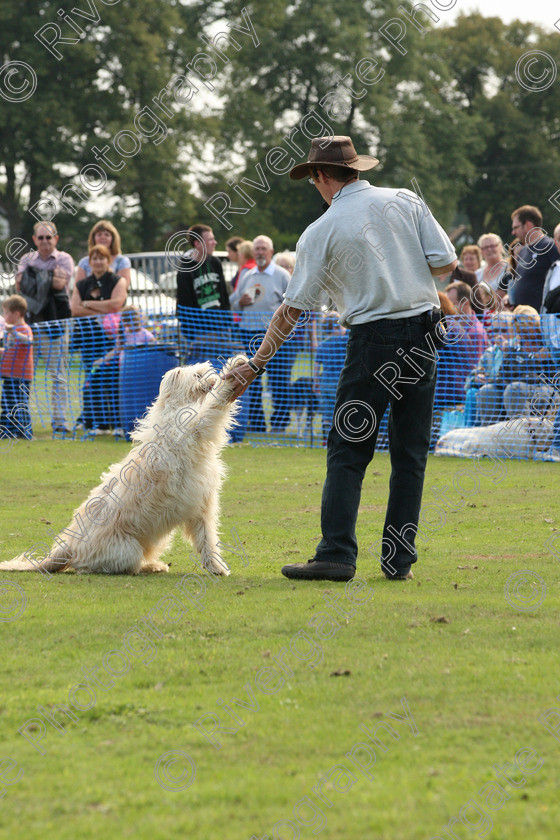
[16, 221, 74, 434]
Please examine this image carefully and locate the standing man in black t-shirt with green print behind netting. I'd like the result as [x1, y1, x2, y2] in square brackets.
[177, 225, 231, 364]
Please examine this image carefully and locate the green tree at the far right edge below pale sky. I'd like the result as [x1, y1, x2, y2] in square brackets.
[440, 14, 560, 241]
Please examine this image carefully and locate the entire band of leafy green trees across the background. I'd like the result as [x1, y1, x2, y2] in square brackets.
[0, 0, 560, 250]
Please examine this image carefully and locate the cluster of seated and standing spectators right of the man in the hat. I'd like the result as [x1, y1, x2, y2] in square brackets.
[435, 206, 560, 461]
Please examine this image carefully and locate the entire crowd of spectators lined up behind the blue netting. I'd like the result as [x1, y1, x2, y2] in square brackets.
[0, 205, 560, 460]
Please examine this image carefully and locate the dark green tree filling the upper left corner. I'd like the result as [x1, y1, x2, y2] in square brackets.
[0, 0, 208, 247]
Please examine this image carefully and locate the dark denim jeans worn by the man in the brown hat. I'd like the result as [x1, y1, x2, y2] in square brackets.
[315, 315, 436, 574]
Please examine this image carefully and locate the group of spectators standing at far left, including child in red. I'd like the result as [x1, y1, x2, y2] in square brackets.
[0, 220, 131, 437]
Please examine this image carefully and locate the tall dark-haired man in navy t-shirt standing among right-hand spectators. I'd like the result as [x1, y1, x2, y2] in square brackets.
[508, 204, 560, 312]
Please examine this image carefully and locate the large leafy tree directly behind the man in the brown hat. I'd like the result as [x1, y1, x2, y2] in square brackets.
[201, 0, 486, 245]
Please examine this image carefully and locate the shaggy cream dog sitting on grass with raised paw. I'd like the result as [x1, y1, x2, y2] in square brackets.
[0, 356, 246, 575]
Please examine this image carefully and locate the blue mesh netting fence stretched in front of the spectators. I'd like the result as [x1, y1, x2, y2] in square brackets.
[0, 308, 560, 458]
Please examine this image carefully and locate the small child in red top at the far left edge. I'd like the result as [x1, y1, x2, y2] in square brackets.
[0, 295, 33, 440]
